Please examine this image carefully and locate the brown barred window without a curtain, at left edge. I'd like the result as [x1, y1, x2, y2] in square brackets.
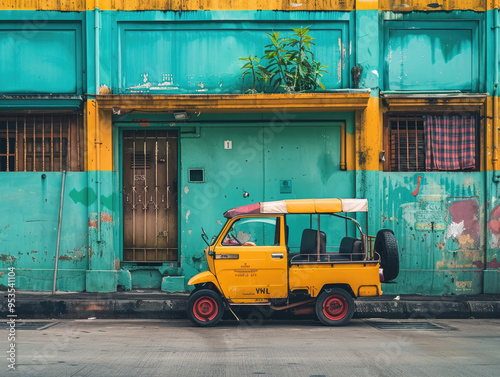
[0, 114, 84, 172]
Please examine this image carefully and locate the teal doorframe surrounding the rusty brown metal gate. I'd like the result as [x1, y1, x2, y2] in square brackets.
[112, 121, 182, 268]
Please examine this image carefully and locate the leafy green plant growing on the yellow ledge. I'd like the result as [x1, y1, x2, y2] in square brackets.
[240, 27, 328, 93]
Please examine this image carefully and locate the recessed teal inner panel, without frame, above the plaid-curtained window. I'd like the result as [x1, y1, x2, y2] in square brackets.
[384, 21, 479, 92]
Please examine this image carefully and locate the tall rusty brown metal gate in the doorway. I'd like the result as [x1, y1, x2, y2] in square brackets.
[123, 130, 178, 262]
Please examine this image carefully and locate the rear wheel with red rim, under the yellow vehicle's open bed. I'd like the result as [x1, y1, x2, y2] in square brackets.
[316, 288, 354, 326]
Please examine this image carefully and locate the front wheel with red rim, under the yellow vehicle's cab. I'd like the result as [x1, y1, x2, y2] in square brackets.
[187, 289, 224, 327]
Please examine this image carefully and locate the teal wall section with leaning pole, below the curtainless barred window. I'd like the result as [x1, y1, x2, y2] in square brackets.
[0, 172, 89, 291]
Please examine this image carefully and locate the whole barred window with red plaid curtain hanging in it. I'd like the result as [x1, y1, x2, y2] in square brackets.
[384, 114, 480, 172]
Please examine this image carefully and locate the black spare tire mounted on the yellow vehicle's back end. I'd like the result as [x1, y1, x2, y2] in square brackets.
[375, 229, 399, 282]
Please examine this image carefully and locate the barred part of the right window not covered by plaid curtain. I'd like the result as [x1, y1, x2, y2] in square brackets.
[384, 114, 480, 172]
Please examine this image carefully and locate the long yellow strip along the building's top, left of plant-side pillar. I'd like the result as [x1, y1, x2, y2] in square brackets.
[0, 0, 355, 12]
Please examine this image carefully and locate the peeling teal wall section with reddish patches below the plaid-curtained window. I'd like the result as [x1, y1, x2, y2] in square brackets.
[379, 172, 486, 294]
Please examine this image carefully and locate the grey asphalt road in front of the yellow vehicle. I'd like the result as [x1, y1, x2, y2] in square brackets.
[0, 319, 500, 377]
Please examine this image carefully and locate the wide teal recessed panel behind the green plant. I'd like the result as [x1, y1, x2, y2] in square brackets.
[115, 21, 349, 94]
